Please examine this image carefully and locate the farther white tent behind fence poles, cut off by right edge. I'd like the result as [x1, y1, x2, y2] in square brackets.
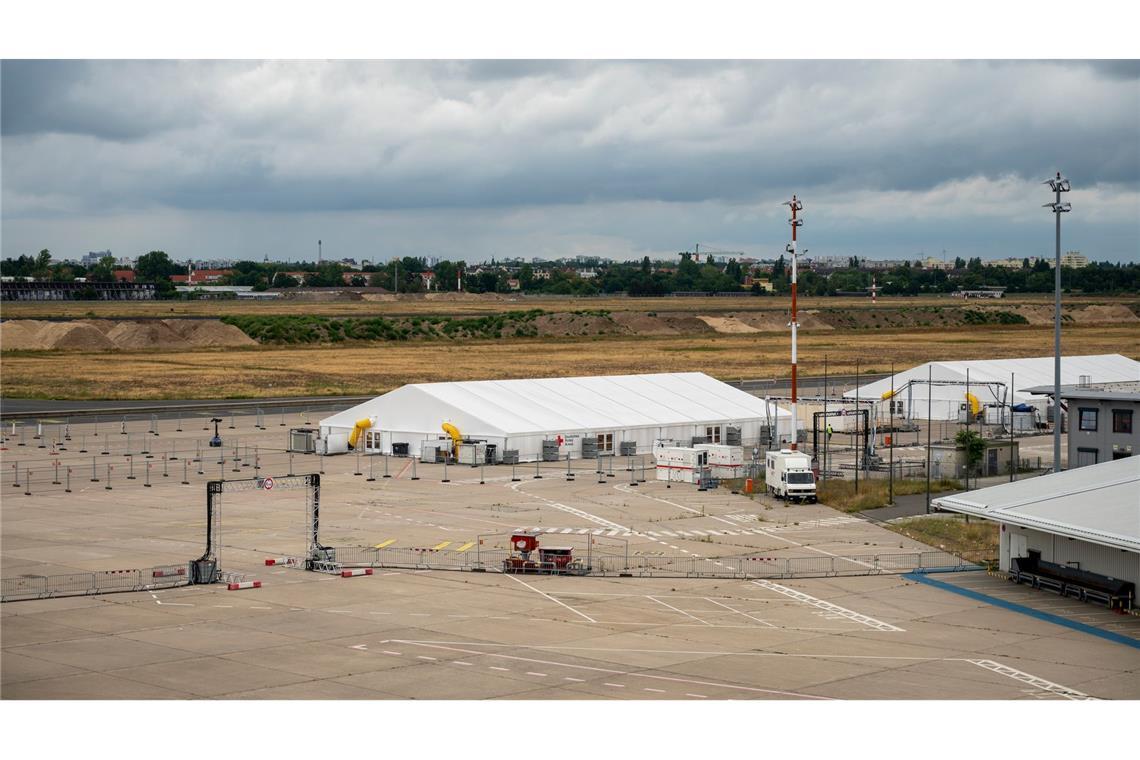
[844, 353, 1140, 419]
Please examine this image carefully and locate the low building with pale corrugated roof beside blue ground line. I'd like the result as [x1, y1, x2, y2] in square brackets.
[933, 457, 1140, 586]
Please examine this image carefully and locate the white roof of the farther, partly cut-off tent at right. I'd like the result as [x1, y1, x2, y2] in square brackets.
[844, 353, 1140, 403]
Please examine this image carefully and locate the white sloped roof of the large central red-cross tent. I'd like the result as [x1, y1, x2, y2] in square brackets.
[320, 373, 790, 435]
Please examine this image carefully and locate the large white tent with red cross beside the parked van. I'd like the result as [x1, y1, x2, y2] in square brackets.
[317, 373, 792, 461]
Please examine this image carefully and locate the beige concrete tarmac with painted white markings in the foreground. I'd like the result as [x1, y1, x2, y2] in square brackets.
[0, 416, 1140, 701]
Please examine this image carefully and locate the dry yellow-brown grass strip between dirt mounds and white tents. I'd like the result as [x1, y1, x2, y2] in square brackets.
[0, 325, 1140, 399]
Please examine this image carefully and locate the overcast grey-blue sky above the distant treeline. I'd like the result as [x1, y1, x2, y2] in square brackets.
[0, 60, 1140, 261]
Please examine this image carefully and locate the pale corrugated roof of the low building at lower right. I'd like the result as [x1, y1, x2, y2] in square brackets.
[933, 457, 1140, 551]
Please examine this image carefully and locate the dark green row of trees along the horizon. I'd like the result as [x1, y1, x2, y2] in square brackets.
[0, 250, 1140, 297]
